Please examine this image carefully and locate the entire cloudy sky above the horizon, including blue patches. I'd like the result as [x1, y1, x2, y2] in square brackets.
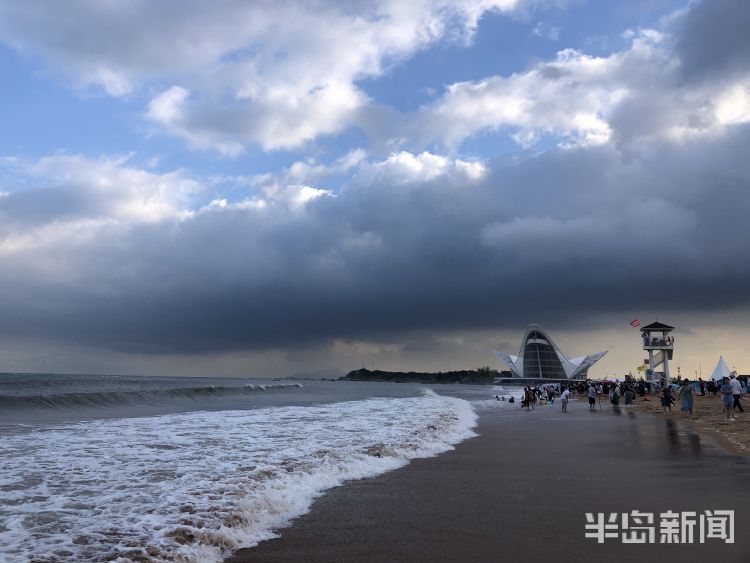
[0, 0, 750, 377]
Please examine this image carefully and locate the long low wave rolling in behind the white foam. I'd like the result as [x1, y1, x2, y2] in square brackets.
[0, 383, 302, 409]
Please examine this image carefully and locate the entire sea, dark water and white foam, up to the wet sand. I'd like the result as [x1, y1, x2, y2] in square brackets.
[0, 374, 510, 562]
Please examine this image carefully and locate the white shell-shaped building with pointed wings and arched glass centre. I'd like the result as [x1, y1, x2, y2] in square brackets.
[492, 324, 607, 379]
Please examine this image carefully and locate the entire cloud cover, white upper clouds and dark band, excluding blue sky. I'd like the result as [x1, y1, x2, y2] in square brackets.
[0, 0, 750, 374]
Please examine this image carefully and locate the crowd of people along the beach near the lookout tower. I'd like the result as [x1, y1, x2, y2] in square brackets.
[496, 374, 750, 422]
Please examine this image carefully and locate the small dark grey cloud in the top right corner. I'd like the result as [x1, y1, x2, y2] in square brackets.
[676, 0, 750, 79]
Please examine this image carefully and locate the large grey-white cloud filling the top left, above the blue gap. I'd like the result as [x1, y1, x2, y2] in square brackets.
[0, 0, 537, 152]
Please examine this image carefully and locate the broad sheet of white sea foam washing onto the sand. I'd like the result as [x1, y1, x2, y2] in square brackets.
[0, 392, 476, 561]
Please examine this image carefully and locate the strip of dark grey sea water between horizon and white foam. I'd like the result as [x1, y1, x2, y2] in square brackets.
[0, 374, 446, 433]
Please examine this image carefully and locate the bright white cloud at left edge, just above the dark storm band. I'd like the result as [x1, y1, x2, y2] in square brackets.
[0, 155, 204, 251]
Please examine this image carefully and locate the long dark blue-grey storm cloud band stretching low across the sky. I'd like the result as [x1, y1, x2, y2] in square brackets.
[0, 126, 750, 353]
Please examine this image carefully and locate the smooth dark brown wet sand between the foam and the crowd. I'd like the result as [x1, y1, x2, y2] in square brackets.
[227, 401, 750, 563]
